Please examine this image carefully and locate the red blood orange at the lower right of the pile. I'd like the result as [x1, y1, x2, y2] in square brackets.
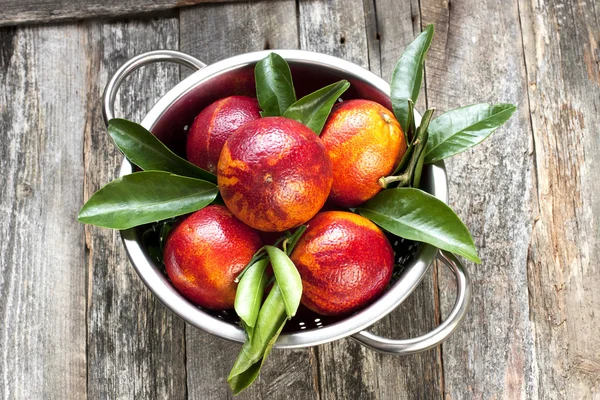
[291, 211, 394, 315]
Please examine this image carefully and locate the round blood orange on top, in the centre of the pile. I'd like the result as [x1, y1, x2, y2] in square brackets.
[217, 117, 333, 232]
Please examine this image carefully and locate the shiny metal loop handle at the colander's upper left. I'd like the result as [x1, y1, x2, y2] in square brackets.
[102, 50, 206, 126]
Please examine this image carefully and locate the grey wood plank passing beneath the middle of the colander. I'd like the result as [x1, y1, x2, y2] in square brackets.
[180, 0, 318, 400]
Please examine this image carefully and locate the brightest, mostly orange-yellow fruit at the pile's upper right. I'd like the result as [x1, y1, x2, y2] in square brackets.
[321, 100, 406, 207]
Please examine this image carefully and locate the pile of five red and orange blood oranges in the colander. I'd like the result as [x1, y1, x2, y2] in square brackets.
[163, 92, 407, 315]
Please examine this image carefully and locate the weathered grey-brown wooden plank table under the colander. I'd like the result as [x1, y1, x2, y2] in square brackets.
[0, 0, 600, 399]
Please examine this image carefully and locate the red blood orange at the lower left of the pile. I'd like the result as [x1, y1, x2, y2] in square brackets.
[164, 205, 262, 310]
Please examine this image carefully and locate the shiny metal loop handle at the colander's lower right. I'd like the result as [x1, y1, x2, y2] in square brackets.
[352, 250, 471, 355]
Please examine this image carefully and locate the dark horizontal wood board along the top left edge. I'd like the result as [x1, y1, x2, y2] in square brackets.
[0, 0, 248, 26]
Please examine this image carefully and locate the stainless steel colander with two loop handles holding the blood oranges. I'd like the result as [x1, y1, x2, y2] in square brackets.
[103, 50, 471, 354]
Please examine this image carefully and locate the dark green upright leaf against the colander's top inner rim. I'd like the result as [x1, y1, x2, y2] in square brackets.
[254, 53, 296, 117]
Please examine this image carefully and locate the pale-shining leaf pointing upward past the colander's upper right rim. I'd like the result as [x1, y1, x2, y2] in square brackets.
[390, 25, 434, 132]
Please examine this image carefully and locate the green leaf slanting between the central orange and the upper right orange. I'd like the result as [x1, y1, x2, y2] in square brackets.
[283, 80, 350, 135]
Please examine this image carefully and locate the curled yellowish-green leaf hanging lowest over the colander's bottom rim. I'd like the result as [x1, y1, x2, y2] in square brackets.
[227, 282, 287, 394]
